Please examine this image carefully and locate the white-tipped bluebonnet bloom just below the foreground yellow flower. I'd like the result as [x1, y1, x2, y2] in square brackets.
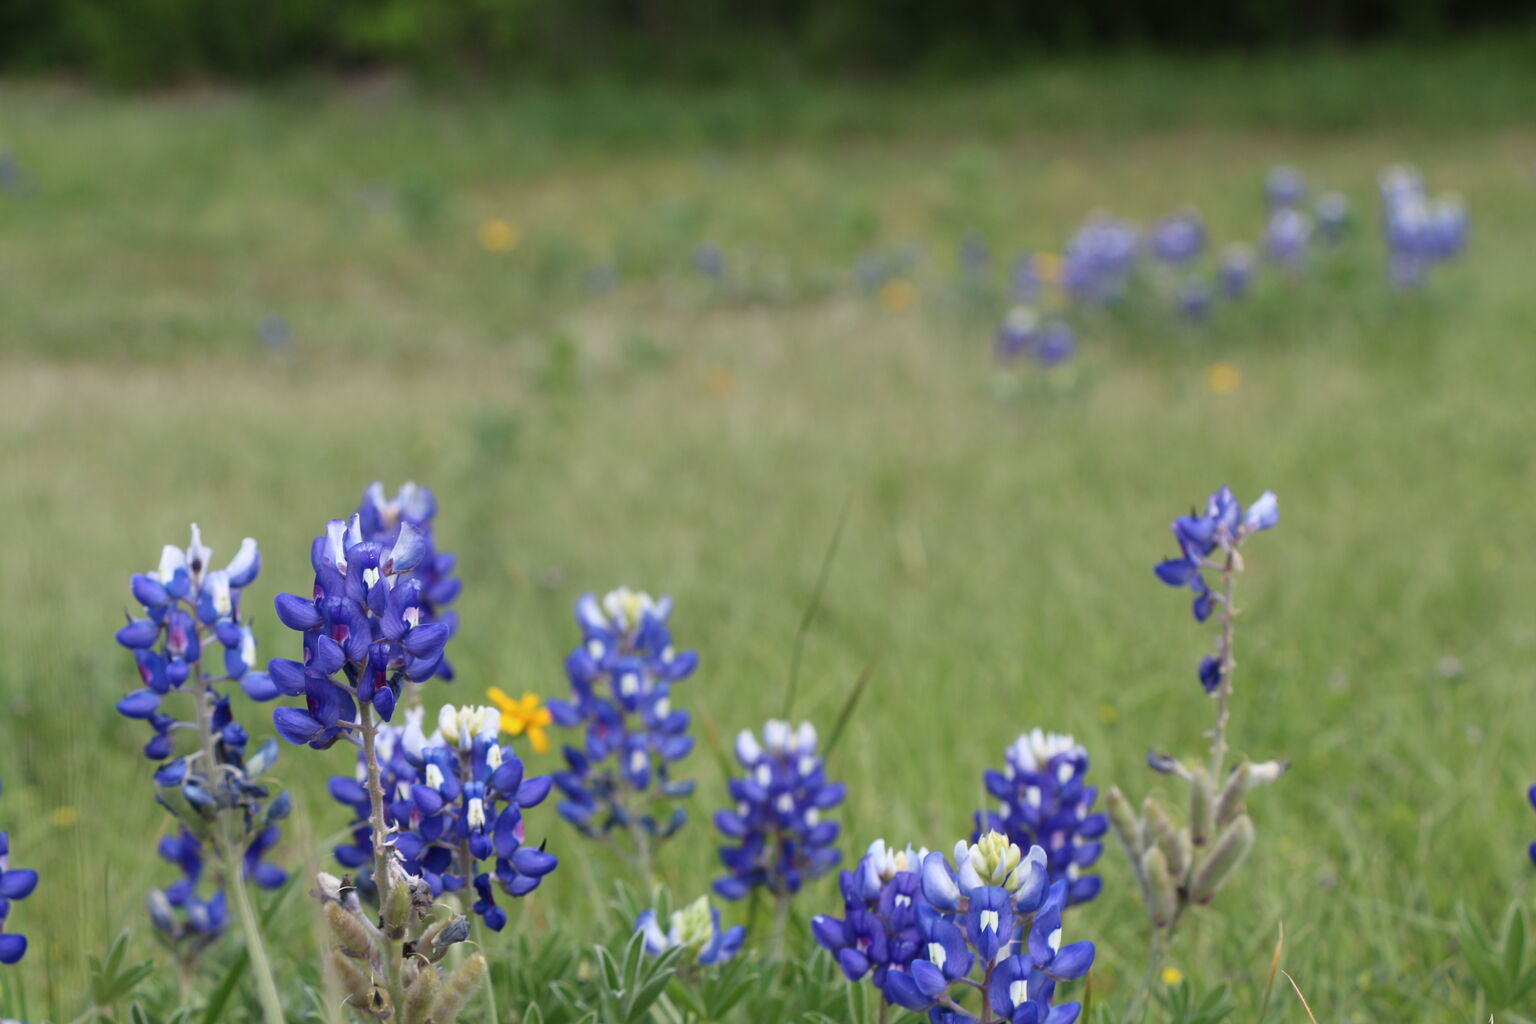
[330, 705, 558, 932]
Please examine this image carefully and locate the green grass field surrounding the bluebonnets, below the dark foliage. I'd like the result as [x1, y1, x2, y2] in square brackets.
[0, 48, 1536, 1022]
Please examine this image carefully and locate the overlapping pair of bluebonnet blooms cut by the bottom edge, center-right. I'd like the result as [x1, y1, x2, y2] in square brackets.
[811, 832, 1095, 1024]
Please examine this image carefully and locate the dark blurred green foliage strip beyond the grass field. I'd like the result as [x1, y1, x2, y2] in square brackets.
[0, 0, 1530, 84]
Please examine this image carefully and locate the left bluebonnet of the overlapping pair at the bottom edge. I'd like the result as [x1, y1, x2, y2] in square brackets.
[811, 840, 928, 992]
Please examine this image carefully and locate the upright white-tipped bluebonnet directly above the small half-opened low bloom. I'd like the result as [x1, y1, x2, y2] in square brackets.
[714, 720, 846, 900]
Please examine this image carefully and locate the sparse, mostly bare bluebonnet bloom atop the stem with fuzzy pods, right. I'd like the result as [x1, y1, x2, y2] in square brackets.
[1155, 487, 1279, 694]
